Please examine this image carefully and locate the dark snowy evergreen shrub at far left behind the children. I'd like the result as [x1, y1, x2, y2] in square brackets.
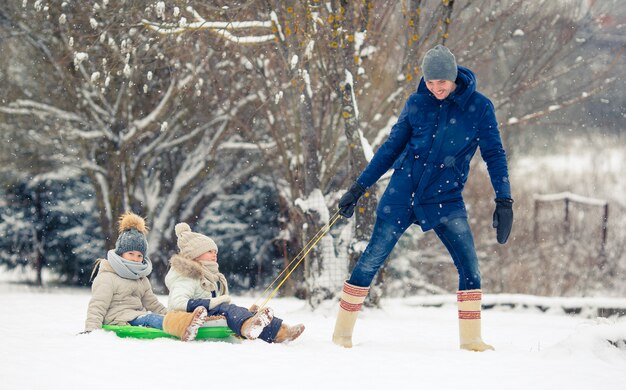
[0, 170, 105, 285]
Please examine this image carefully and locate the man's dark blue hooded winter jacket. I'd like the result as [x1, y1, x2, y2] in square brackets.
[357, 66, 511, 231]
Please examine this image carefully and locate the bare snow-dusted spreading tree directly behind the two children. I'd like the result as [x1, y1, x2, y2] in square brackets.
[0, 1, 257, 280]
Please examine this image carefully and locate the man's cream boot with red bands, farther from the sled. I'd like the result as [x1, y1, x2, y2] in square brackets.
[456, 290, 494, 352]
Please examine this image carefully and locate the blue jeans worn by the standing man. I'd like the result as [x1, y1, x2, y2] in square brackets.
[348, 218, 480, 290]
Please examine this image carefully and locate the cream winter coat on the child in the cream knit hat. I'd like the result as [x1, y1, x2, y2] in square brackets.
[165, 255, 228, 311]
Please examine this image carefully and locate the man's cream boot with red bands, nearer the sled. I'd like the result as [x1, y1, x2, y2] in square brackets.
[333, 281, 370, 348]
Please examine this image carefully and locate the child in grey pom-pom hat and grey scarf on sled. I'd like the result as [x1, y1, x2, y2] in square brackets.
[85, 212, 207, 341]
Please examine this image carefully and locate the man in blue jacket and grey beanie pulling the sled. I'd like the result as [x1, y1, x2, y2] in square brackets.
[333, 45, 513, 351]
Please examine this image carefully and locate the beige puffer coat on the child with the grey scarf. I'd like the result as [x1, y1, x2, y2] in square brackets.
[85, 259, 167, 330]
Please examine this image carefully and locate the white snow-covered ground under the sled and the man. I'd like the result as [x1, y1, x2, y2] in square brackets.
[0, 283, 626, 390]
